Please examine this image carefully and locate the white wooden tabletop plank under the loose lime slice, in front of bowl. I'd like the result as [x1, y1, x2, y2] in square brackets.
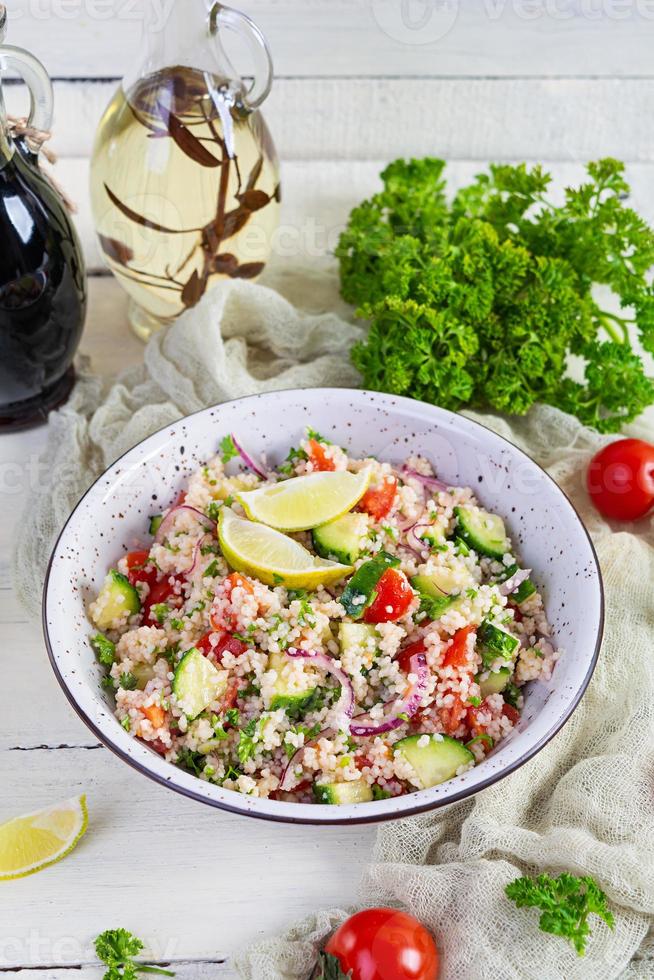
[0, 748, 374, 968]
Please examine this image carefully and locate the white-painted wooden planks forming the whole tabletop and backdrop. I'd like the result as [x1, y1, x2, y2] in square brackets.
[0, 0, 654, 980]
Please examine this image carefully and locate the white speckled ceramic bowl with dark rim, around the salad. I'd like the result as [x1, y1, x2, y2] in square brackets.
[43, 389, 603, 823]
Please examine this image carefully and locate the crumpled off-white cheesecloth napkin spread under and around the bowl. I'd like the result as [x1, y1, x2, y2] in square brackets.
[14, 263, 654, 980]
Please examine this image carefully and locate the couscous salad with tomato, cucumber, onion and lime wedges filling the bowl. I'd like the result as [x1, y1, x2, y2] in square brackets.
[89, 430, 558, 804]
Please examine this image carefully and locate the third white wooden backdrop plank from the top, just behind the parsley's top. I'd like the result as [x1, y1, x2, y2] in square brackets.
[30, 154, 654, 272]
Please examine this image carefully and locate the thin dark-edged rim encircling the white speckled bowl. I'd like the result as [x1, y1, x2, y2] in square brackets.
[41, 387, 606, 826]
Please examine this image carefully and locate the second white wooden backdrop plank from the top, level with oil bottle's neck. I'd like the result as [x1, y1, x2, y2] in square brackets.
[3, 77, 654, 161]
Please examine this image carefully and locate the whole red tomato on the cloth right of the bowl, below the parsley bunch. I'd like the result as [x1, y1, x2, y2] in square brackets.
[586, 439, 654, 521]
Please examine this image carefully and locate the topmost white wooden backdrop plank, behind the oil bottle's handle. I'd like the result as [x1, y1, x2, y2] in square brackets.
[3, 0, 654, 78]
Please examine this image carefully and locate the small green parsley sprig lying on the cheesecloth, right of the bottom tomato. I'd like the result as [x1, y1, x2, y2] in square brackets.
[506, 872, 614, 956]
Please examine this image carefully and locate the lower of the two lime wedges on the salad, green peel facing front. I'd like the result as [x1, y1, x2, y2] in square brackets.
[218, 507, 352, 589]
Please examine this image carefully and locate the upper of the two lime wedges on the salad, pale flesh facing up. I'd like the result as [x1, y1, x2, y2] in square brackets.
[235, 470, 370, 531]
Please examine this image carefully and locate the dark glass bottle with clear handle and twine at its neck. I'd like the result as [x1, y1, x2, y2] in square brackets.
[0, 4, 86, 431]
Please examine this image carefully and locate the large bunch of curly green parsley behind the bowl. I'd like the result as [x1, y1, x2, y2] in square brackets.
[336, 158, 654, 432]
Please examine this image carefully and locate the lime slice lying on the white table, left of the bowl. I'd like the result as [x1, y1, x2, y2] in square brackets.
[0, 796, 88, 881]
